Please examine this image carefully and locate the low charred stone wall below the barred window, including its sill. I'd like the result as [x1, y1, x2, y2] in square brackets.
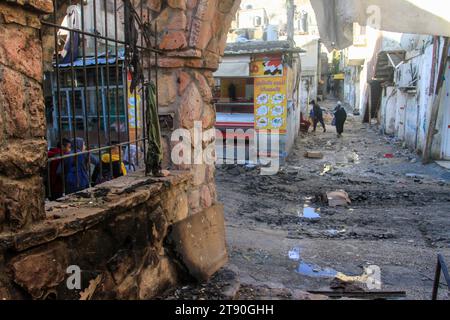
[0, 172, 227, 300]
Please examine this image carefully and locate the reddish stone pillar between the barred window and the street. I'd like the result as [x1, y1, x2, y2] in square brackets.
[147, 0, 240, 214]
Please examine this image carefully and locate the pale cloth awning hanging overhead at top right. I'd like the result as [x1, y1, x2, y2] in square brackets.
[311, 0, 450, 49]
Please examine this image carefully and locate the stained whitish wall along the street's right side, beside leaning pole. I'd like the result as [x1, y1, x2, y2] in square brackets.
[381, 35, 448, 159]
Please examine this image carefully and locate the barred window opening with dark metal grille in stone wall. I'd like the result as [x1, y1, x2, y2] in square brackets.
[42, 0, 159, 200]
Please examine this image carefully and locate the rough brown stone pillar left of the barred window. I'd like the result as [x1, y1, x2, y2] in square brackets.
[0, 0, 53, 232]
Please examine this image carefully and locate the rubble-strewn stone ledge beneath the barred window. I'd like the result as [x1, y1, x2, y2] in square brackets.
[0, 171, 191, 251]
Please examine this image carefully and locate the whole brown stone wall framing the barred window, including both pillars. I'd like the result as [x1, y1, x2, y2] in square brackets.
[0, 0, 240, 300]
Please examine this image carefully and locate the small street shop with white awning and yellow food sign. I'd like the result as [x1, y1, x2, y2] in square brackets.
[214, 42, 301, 164]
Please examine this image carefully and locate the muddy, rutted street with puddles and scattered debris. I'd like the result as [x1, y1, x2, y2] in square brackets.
[216, 101, 450, 299]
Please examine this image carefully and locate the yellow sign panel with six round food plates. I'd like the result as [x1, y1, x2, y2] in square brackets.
[255, 76, 288, 133]
